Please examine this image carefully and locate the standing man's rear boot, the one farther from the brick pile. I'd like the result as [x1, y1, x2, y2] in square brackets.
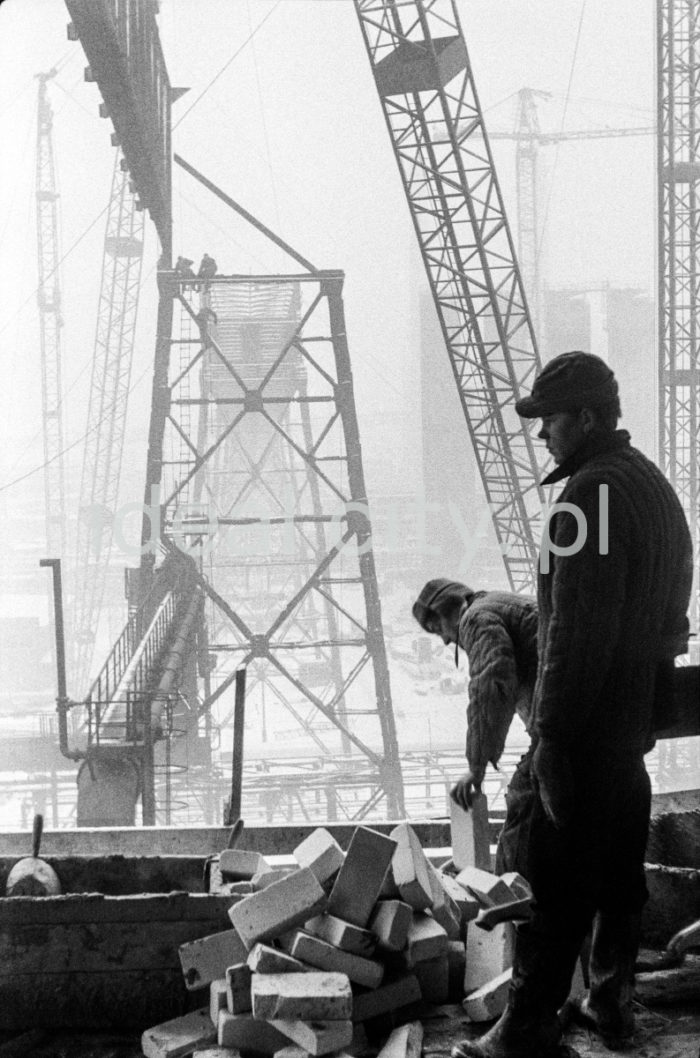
[578, 911, 641, 1051]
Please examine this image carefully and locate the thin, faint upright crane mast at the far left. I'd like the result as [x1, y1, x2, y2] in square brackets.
[36, 70, 66, 558]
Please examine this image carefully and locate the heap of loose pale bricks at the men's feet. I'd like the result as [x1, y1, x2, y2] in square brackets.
[142, 823, 522, 1058]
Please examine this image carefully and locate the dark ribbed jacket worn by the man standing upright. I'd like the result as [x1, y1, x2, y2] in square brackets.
[534, 430, 693, 762]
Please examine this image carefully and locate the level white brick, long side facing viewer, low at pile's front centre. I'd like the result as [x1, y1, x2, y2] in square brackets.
[251, 973, 352, 1021]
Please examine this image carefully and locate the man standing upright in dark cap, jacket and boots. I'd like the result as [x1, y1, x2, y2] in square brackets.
[453, 352, 693, 1058]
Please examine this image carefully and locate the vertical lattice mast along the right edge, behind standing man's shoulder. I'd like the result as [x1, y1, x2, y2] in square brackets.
[657, 0, 700, 651]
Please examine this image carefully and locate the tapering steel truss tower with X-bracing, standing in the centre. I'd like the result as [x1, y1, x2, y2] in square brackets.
[142, 271, 403, 818]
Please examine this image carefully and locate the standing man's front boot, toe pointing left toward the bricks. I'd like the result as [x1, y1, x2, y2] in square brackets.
[452, 913, 586, 1058]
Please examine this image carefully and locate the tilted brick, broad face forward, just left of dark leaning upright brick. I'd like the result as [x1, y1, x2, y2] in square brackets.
[228, 868, 327, 962]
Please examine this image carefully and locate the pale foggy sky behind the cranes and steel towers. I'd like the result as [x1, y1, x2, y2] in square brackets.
[0, 0, 693, 825]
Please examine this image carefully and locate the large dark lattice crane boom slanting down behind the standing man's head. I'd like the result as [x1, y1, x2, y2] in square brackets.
[355, 0, 545, 590]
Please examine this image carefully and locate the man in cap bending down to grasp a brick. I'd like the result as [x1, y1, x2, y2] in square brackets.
[412, 578, 537, 874]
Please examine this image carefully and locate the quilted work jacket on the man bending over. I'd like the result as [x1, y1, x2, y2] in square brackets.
[459, 591, 537, 771]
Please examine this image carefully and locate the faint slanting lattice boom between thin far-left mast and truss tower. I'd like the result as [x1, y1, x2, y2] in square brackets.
[72, 150, 144, 690]
